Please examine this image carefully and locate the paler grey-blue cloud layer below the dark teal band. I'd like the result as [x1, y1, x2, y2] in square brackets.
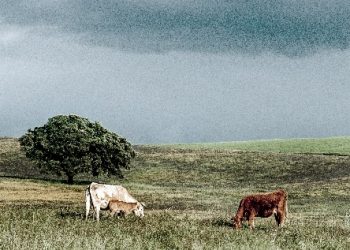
[0, 35, 350, 143]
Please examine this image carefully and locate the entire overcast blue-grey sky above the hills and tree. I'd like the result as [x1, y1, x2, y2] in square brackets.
[0, 0, 350, 143]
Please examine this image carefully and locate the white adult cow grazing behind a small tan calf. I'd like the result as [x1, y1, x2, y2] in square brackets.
[85, 182, 145, 221]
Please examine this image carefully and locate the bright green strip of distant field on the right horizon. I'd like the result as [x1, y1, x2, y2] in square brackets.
[157, 137, 350, 155]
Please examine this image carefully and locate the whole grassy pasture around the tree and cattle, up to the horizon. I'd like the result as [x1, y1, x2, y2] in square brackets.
[0, 138, 350, 249]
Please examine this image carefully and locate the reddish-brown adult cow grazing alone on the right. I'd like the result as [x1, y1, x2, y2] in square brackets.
[232, 189, 288, 229]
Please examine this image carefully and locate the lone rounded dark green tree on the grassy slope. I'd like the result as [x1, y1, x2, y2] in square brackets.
[19, 115, 135, 184]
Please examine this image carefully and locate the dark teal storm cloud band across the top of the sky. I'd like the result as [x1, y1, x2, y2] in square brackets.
[0, 0, 350, 56]
